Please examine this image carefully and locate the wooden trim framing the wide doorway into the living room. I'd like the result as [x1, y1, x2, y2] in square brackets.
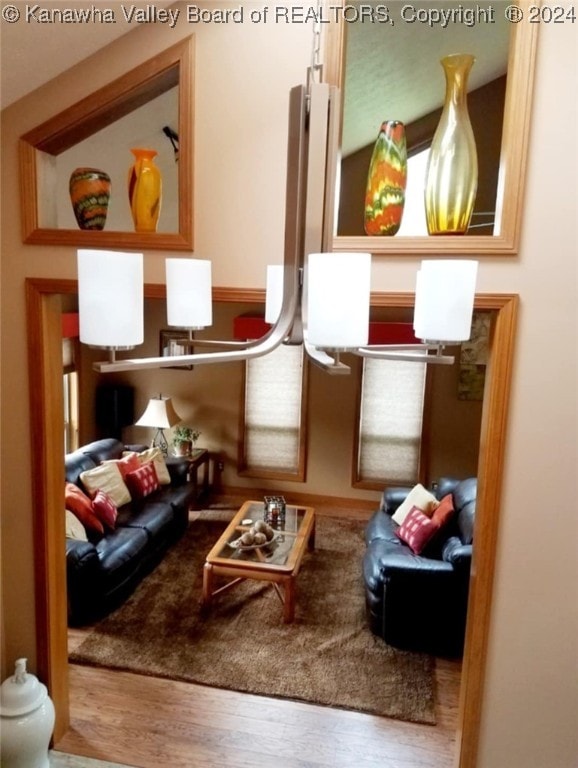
[26, 278, 518, 768]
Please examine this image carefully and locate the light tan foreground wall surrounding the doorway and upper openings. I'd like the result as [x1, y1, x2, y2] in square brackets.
[1, 7, 578, 768]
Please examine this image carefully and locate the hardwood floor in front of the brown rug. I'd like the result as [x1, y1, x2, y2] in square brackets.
[51, 500, 461, 768]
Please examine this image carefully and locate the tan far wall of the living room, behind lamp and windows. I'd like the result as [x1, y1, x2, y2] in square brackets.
[80, 300, 482, 496]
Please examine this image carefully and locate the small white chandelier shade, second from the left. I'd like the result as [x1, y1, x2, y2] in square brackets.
[165, 259, 213, 328]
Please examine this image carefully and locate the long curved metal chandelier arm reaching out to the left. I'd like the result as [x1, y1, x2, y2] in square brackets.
[93, 85, 309, 373]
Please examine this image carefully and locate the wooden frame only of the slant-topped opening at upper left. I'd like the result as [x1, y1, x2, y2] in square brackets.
[19, 35, 194, 250]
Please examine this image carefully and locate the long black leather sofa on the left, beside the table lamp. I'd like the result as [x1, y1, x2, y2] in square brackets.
[65, 438, 194, 626]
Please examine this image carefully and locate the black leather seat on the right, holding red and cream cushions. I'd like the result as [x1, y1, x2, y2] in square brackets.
[363, 477, 477, 656]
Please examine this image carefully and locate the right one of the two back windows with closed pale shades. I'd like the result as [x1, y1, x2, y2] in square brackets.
[355, 359, 426, 487]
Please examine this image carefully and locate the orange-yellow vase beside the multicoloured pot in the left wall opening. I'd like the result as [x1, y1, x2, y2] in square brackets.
[128, 149, 162, 232]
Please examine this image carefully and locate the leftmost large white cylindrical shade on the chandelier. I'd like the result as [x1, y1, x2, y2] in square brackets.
[77, 249, 144, 348]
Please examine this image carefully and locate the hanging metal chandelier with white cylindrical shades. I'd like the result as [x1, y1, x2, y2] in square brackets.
[78, 81, 478, 374]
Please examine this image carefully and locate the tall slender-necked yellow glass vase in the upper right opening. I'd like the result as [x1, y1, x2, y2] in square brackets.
[425, 53, 478, 235]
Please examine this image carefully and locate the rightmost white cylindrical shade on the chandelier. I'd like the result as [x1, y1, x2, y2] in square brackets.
[414, 259, 478, 342]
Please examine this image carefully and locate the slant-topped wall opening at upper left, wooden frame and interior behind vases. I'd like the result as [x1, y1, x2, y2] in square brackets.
[19, 36, 194, 250]
